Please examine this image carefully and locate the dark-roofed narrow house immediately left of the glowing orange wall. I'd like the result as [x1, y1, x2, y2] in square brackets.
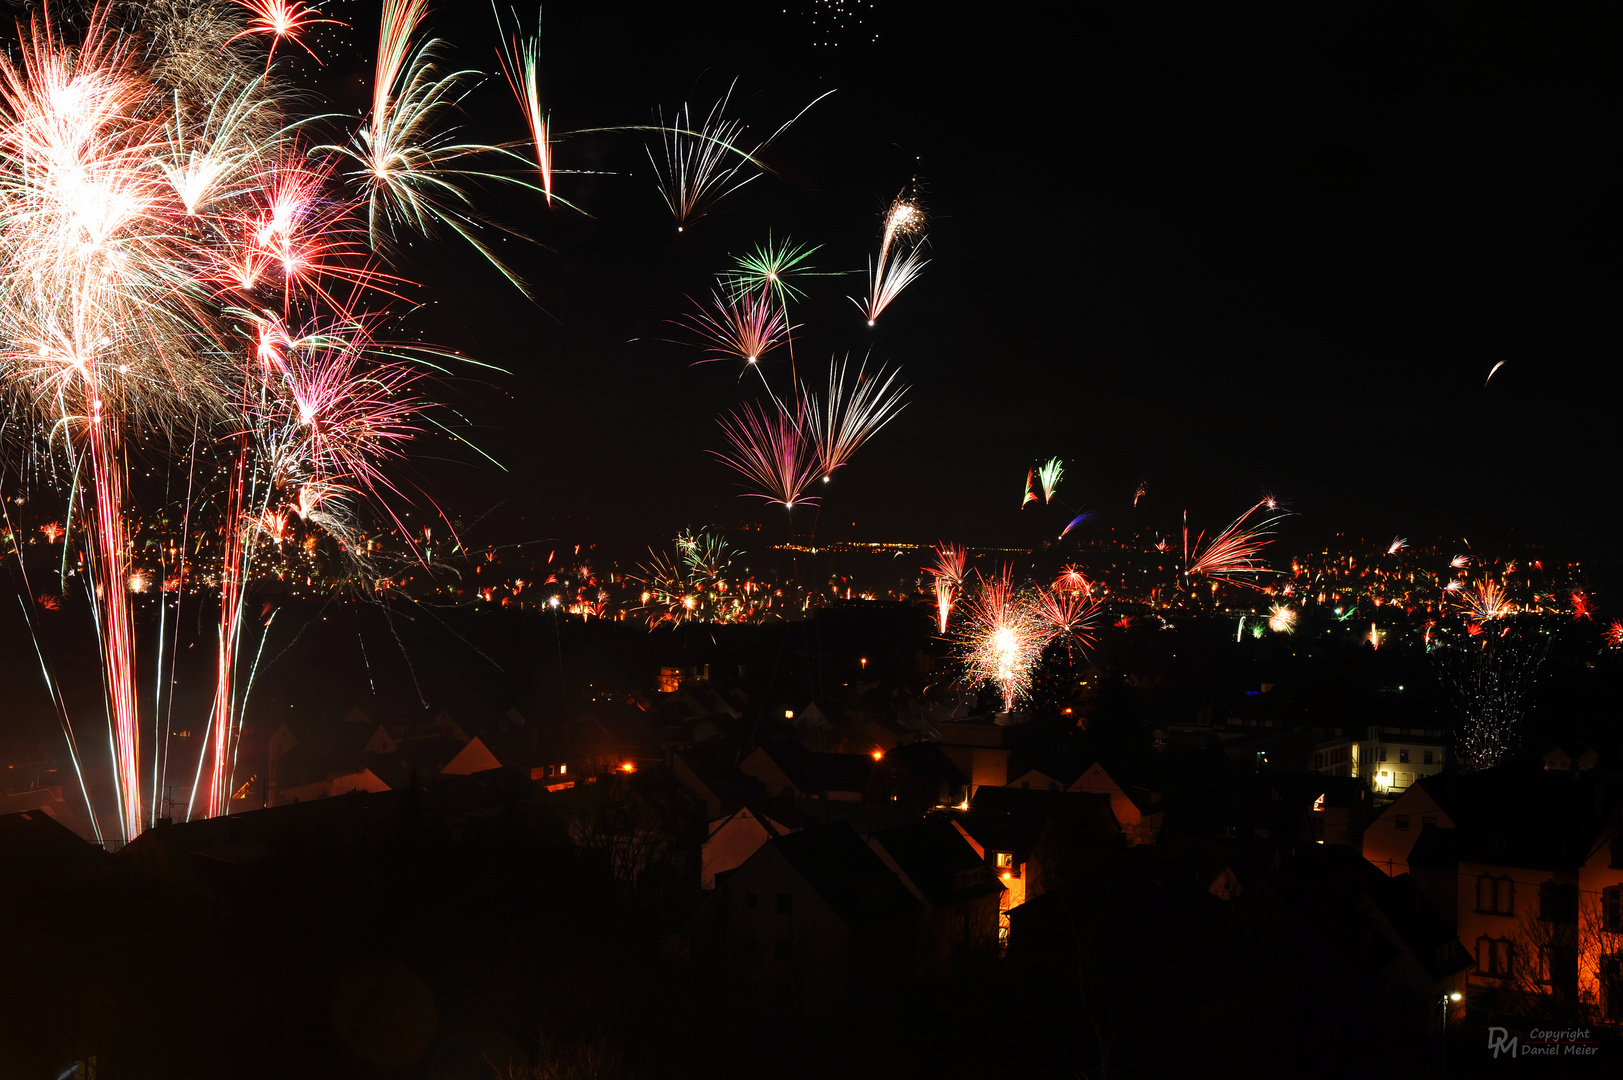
[868, 814, 1005, 978]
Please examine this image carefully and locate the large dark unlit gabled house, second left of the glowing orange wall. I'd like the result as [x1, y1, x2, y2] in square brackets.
[716, 823, 920, 1017]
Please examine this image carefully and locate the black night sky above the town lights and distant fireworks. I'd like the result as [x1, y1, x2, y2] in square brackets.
[309, 0, 1623, 557]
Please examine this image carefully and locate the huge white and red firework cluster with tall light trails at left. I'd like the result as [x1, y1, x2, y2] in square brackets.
[0, 0, 626, 840]
